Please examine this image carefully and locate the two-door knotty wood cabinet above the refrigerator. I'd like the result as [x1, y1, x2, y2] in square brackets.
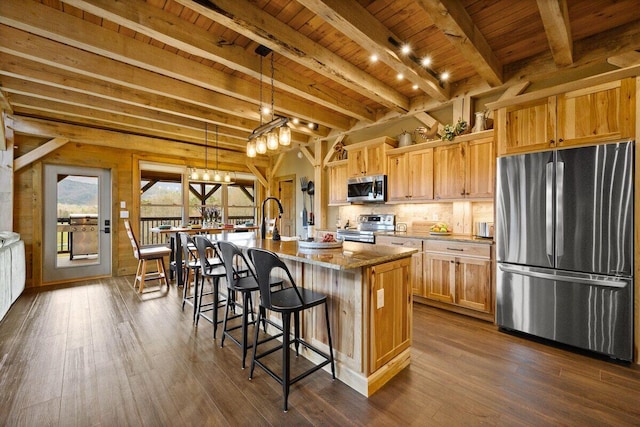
[496, 78, 635, 156]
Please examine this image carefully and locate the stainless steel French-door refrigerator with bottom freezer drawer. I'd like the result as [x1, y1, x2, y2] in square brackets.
[495, 141, 634, 360]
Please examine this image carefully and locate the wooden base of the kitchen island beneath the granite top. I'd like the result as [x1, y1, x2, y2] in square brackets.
[282, 257, 412, 396]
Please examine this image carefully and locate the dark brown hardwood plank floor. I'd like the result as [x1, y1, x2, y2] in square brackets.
[0, 277, 640, 426]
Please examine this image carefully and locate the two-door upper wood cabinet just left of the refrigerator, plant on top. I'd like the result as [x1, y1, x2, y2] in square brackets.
[434, 131, 495, 200]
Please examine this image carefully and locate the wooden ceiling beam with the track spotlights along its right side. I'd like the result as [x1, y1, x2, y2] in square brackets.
[298, 0, 449, 101]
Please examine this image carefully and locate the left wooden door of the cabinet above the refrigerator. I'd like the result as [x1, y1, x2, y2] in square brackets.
[496, 96, 556, 156]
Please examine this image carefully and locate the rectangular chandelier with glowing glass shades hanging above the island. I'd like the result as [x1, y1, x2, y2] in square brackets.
[247, 46, 291, 157]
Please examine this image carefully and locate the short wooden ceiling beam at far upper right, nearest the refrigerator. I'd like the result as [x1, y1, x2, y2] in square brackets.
[537, 0, 573, 67]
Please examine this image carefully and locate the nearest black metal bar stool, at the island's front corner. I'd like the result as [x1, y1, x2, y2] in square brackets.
[249, 248, 336, 412]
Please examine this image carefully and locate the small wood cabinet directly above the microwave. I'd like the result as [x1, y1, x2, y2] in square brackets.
[345, 136, 398, 178]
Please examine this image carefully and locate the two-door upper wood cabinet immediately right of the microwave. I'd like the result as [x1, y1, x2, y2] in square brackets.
[387, 146, 433, 203]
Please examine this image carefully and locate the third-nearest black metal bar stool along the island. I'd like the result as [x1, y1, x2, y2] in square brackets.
[193, 236, 230, 339]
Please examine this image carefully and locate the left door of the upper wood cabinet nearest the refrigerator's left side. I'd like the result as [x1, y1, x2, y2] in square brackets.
[434, 144, 465, 200]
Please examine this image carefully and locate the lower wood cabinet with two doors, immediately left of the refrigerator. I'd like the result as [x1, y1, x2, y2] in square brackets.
[423, 240, 494, 320]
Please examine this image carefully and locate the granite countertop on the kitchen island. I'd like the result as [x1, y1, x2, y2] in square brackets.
[226, 239, 418, 270]
